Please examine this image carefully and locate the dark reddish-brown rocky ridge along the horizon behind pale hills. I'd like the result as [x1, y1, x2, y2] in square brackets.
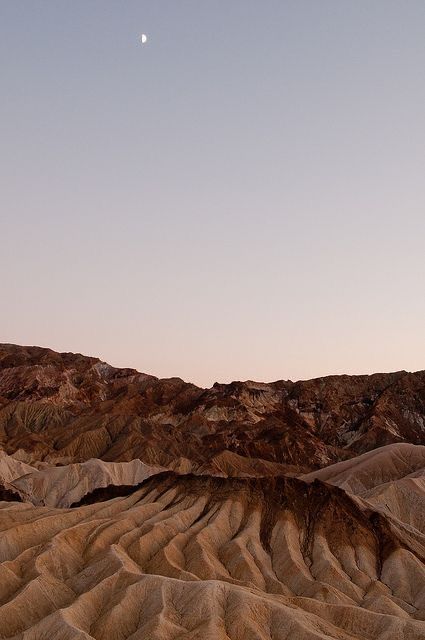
[0, 345, 425, 471]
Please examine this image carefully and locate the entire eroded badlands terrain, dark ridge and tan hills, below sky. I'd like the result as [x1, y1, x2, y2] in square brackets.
[0, 345, 425, 640]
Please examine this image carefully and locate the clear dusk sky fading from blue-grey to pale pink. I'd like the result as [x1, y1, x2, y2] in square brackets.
[0, 0, 425, 386]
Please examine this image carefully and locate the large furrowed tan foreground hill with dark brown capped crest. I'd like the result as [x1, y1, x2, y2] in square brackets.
[0, 472, 425, 640]
